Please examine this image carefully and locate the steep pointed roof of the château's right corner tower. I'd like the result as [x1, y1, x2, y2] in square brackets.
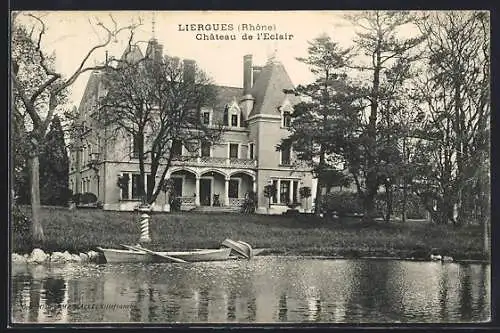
[250, 60, 299, 116]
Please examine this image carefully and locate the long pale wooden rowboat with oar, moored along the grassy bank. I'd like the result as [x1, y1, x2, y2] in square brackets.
[98, 247, 231, 263]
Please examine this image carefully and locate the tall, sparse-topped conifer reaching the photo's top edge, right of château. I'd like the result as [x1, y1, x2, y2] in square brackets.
[349, 11, 423, 221]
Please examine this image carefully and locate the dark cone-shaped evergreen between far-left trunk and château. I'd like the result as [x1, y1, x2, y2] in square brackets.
[40, 115, 70, 205]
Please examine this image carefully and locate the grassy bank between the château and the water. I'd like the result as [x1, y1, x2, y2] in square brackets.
[13, 207, 484, 260]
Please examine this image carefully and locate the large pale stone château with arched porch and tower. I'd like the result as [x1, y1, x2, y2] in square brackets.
[69, 39, 314, 214]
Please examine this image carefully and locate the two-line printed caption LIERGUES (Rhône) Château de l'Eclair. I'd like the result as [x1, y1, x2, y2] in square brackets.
[177, 23, 294, 41]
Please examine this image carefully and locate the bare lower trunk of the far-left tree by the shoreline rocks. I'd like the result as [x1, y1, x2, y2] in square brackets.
[30, 154, 45, 247]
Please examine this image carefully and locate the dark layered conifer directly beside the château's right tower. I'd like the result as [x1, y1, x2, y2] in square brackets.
[281, 35, 360, 214]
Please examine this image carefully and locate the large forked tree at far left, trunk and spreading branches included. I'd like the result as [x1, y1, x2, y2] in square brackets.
[10, 13, 140, 246]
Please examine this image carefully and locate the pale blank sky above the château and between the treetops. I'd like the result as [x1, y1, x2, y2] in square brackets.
[13, 11, 355, 106]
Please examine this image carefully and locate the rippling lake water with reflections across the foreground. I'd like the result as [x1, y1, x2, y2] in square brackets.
[11, 256, 491, 323]
